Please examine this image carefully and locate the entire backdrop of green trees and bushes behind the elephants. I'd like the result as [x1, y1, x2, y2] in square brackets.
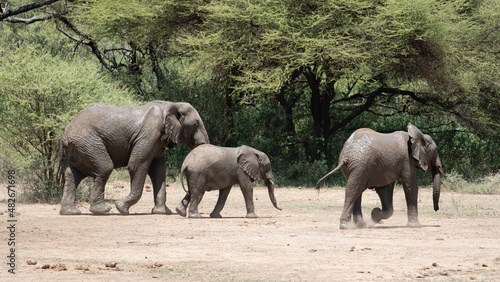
[0, 0, 500, 196]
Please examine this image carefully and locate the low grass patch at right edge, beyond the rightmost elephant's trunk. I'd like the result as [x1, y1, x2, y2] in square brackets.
[442, 171, 500, 194]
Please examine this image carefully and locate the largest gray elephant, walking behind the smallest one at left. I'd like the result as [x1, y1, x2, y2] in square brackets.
[60, 101, 209, 215]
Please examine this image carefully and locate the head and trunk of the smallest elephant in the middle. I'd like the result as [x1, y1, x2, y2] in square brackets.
[237, 146, 281, 210]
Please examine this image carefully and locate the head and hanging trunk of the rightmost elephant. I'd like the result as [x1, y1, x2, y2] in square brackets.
[408, 123, 444, 211]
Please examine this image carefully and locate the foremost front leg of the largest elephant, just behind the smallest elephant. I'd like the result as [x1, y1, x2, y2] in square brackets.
[148, 158, 172, 215]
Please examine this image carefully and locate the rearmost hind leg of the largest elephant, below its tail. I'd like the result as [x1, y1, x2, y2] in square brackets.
[59, 165, 87, 215]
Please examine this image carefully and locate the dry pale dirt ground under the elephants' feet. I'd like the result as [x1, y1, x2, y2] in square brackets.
[0, 182, 500, 281]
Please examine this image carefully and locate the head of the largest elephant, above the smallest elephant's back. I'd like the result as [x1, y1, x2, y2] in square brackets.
[163, 101, 210, 149]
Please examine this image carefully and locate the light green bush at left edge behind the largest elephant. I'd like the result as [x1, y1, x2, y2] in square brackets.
[0, 28, 136, 201]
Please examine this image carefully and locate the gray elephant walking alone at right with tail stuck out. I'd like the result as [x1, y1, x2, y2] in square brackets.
[316, 124, 444, 229]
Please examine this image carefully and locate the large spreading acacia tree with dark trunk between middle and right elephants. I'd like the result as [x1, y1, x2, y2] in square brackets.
[179, 0, 499, 160]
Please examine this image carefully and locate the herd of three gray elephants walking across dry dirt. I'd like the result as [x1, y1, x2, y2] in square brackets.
[59, 101, 444, 229]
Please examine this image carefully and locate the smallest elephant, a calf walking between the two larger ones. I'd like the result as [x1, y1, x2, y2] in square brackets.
[176, 144, 281, 218]
